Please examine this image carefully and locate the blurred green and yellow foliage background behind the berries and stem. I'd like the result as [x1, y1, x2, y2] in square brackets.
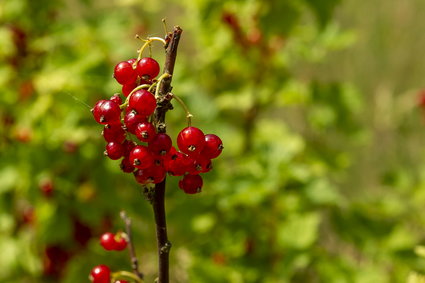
[0, 0, 425, 283]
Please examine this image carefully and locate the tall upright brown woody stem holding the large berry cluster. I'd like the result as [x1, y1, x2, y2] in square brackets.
[152, 27, 182, 283]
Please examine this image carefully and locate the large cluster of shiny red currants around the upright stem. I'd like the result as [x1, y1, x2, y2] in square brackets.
[92, 57, 223, 194]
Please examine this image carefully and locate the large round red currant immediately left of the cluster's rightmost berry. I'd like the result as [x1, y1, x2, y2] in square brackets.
[177, 127, 205, 156]
